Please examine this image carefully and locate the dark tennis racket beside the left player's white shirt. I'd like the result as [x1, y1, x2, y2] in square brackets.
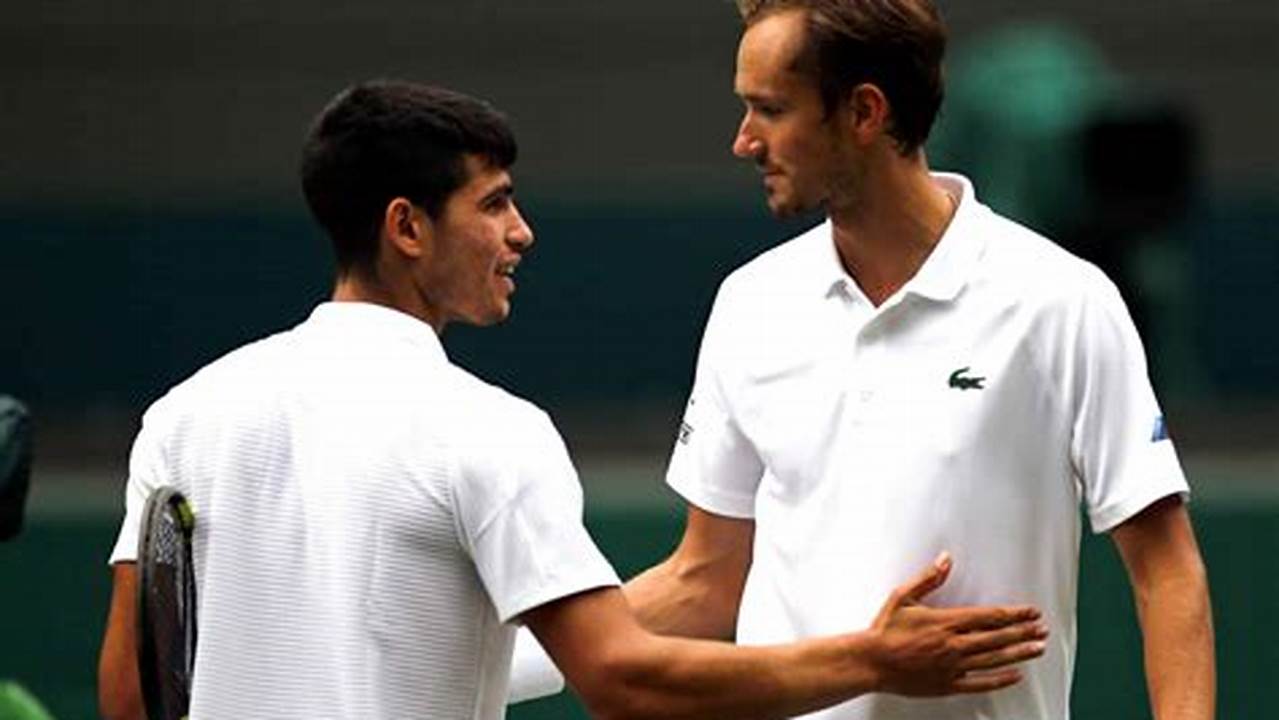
[137, 487, 196, 720]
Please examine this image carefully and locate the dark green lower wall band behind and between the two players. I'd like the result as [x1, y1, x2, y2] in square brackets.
[0, 499, 1279, 720]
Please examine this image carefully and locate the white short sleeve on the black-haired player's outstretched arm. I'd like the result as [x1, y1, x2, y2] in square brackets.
[454, 407, 620, 622]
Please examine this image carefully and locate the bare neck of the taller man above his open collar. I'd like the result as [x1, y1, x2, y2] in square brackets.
[830, 151, 958, 307]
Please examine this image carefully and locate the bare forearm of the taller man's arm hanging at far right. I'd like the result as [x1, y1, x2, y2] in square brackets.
[1137, 568, 1216, 720]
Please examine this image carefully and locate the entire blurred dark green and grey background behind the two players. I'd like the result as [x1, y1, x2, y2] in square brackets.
[0, 0, 1279, 720]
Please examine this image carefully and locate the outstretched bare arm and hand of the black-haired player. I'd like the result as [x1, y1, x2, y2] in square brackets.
[523, 559, 1045, 720]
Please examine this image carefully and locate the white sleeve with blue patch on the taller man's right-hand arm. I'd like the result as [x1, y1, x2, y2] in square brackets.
[1071, 278, 1189, 532]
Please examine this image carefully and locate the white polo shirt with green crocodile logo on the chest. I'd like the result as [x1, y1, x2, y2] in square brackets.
[668, 174, 1187, 720]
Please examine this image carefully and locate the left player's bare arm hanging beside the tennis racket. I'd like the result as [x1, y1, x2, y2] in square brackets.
[97, 563, 146, 720]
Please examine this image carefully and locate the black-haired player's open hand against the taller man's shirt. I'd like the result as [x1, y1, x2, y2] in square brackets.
[871, 552, 1048, 697]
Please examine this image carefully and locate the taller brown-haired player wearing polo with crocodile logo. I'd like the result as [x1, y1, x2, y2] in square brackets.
[578, 0, 1215, 720]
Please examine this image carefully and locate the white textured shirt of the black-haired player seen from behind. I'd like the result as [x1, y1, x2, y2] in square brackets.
[111, 303, 618, 720]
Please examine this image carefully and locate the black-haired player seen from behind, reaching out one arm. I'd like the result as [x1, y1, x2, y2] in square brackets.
[100, 82, 1045, 720]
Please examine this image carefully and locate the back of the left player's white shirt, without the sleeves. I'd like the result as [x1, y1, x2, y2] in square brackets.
[147, 306, 515, 719]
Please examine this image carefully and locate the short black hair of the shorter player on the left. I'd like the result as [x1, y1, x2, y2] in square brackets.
[301, 81, 518, 274]
